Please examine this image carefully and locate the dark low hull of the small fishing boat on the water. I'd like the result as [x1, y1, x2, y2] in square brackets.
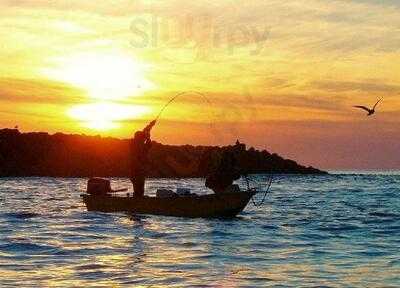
[81, 191, 254, 218]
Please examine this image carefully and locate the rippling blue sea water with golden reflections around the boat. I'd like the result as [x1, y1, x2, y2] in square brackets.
[0, 172, 400, 287]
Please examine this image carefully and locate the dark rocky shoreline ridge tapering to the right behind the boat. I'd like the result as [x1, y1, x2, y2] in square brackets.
[0, 129, 326, 178]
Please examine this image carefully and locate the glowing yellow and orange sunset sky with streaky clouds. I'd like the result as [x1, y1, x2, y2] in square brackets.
[0, 0, 400, 169]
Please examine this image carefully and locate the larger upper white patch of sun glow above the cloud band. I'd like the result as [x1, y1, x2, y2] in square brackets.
[45, 53, 154, 100]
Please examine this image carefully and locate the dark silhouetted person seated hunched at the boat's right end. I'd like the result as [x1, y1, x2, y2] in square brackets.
[205, 149, 240, 194]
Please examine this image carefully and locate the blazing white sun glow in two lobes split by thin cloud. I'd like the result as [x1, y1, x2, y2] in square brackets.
[44, 52, 154, 131]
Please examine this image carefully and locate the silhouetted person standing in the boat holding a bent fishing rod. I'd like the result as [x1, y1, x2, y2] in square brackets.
[130, 120, 156, 197]
